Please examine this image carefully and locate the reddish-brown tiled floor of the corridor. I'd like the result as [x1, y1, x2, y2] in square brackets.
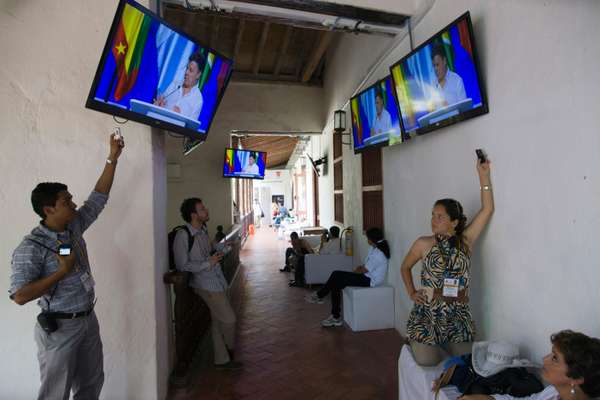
[171, 228, 402, 400]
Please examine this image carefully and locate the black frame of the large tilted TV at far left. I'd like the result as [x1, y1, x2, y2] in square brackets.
[85, 0, 233, 141]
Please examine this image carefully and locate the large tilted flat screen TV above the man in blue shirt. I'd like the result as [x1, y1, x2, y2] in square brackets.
[86, 0, 233, 140]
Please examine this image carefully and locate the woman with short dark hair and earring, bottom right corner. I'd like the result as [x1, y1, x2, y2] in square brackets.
[460, 330, 600, 400]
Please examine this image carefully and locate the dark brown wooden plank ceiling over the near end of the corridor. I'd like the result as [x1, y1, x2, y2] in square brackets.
[163, 3, 334, 86]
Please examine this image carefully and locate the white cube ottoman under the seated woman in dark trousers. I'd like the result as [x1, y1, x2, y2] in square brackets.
[342, 285, 395, 332]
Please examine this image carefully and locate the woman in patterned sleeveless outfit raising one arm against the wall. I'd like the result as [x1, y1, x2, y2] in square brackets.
[401, 155, 494, 366]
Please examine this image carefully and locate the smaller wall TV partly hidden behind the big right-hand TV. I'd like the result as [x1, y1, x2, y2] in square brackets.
[350, 76, 402, 153]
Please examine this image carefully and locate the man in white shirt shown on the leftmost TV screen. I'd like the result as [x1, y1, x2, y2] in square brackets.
[154, 53, 206, 120]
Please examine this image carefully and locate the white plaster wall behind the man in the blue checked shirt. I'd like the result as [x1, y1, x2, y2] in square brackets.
[0, 1, 170, 400]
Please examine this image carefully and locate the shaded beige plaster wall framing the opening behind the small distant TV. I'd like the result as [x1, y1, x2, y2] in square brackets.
[167, 82, 323, 231]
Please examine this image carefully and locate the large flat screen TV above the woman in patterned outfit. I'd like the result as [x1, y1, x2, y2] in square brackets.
[390, 11, 488, 136]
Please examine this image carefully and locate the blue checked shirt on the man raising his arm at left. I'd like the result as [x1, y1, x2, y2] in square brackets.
[8, 192, 108, 313]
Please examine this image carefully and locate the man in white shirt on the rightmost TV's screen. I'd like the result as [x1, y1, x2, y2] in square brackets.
[431, 46, 467, 107]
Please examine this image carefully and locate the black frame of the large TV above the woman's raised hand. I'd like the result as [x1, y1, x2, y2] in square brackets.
[390, 11, 489, 137]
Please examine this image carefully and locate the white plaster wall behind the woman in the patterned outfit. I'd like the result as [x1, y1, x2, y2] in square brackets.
[314, 0, 600, 359]
